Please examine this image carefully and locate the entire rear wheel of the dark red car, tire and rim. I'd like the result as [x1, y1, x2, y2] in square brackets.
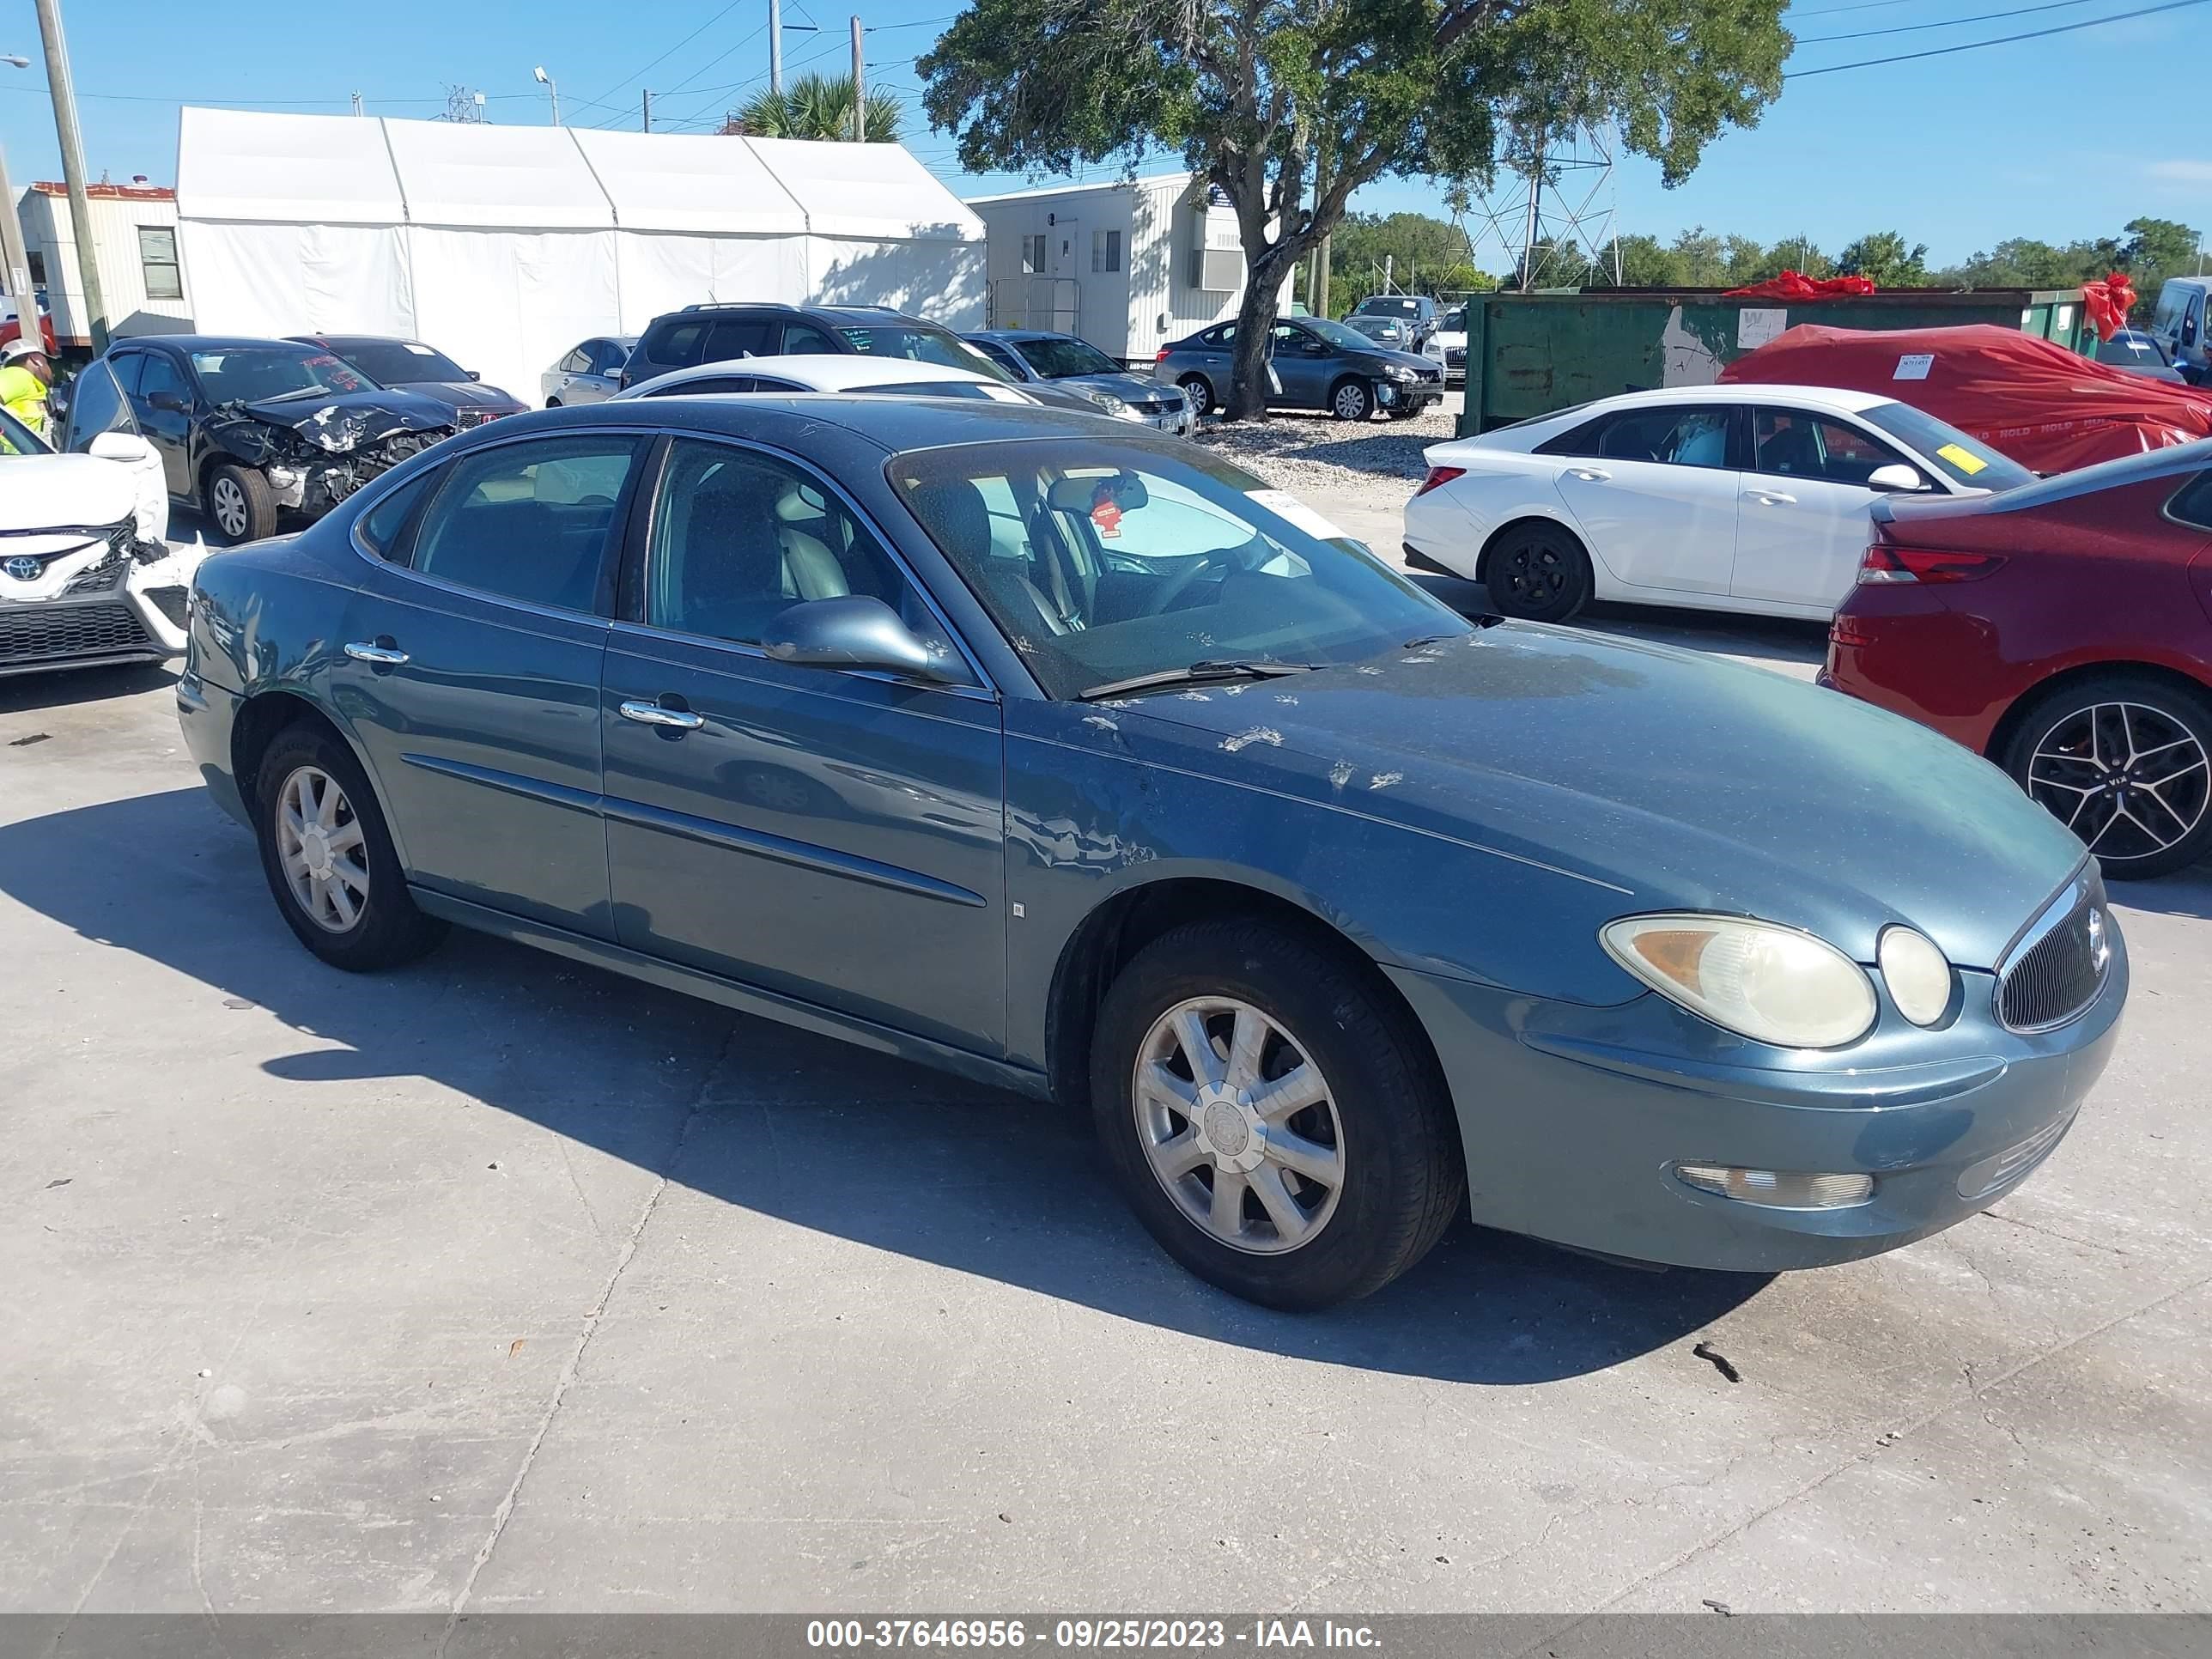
[1996, 671, 2212, 880]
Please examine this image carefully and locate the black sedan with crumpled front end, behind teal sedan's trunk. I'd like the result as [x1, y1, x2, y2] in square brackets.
[88, 334, 453, 542]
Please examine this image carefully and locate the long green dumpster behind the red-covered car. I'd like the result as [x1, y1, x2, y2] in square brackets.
[1460, 288, 2097, 438]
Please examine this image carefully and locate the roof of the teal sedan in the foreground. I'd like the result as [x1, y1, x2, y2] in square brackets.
[524, 391, 1141, 453]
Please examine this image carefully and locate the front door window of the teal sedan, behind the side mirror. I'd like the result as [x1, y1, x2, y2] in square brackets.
[644, 438, 960, 664]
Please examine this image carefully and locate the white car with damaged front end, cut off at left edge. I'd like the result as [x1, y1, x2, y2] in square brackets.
[0, 402, 201, 677]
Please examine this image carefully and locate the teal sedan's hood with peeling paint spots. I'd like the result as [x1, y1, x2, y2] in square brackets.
[1117, 622, 2084, 969]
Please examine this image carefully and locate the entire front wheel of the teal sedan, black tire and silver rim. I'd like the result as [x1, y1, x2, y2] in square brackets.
[1091, 918, 1467, 1312]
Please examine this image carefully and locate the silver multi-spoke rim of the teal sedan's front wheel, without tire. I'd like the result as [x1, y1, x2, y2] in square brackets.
[1130, 998, 1345, 1256]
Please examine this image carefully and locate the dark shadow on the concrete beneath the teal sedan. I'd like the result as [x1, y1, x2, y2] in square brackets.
[0, 790, 1765, 1385]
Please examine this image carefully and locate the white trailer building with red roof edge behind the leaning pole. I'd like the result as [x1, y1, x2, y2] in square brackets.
[18, 184, 192, 349]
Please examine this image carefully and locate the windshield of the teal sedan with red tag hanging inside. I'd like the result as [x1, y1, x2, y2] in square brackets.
[890, 438, 1471, 699]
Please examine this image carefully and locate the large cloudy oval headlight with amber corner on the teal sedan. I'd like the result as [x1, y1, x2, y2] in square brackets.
[1599, 914, 1875, 1048]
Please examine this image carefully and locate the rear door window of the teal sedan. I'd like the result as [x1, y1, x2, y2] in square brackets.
[411, 434, 644, 615]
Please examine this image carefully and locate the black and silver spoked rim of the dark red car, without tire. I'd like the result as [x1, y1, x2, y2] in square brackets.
[2028, 703, 2212, 863]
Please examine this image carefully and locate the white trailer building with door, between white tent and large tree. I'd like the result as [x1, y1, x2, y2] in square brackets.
[967, 173, 1243, 368]
